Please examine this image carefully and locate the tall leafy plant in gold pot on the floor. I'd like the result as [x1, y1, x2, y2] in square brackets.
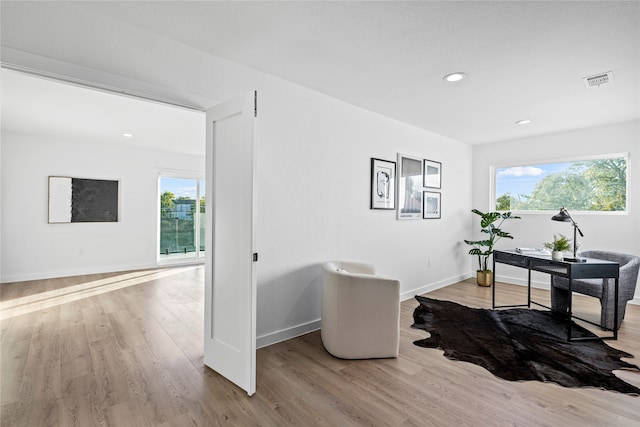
[464, 209, 520, 286]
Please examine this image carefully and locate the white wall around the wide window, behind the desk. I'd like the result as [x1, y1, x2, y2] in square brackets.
[473, 121, 640, 303]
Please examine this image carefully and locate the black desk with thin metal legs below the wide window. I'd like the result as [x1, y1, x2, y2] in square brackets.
[491, 251, 620, 341]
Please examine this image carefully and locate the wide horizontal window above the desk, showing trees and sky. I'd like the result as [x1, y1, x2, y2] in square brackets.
[494, 154, 629, 212]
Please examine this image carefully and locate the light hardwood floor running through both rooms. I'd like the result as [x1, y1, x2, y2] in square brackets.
[0, 267, 640, 427]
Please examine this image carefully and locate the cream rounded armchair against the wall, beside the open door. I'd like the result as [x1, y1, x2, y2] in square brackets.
[321, 261, 400, 359]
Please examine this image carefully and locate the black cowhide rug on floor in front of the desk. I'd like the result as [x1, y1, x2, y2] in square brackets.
[411, 296, 640, 396]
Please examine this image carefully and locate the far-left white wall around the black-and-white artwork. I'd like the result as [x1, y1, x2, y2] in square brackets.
[1, 132, 204, 283]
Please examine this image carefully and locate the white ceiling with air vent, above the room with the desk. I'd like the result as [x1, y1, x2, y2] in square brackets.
[1, 1, 640, 150]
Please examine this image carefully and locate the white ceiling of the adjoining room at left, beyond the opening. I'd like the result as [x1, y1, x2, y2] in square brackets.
[1, 70, 205, 155]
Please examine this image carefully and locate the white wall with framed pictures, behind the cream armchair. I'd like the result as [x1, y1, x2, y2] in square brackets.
[257, 80, 471, 345]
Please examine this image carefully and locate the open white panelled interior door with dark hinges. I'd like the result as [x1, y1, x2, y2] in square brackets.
[204, 92, 257, 395]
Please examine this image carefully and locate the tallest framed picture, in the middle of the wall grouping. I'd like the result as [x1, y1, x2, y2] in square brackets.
[397, 154, 423, 219]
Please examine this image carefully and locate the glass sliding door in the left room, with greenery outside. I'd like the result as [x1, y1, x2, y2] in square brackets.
[158, 176, 205, 260]
